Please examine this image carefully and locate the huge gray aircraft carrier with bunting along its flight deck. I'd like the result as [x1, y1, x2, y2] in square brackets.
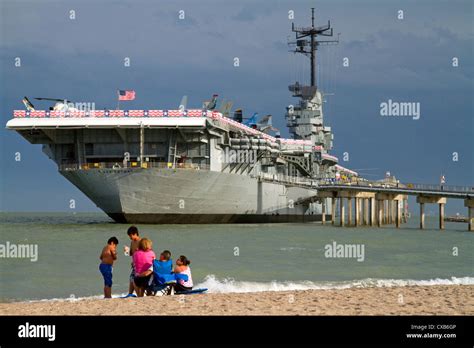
[7, 10, 357, 224]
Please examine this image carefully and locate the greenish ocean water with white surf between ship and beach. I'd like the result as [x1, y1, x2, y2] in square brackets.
[0, 213, 474, 302]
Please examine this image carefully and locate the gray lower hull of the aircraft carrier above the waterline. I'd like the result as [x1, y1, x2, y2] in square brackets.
[60, 168, 321, 224]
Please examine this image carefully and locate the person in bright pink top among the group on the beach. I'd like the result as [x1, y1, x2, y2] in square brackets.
[133, 238, 156, 297]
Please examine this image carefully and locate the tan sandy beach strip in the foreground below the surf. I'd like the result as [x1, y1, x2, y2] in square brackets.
[0, 285, 474, 315]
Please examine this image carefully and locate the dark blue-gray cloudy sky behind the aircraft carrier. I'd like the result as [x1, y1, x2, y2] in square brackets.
[0, 0, 474, 213]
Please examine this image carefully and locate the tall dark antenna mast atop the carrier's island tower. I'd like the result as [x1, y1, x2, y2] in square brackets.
[289, 7, 339, 87]
